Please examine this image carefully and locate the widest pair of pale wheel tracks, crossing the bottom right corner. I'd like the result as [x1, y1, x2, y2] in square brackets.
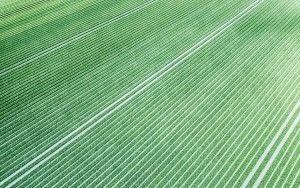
[250, 103, 300, 188]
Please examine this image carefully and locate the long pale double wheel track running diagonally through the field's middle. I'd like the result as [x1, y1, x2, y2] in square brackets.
[0, 1, 257, 187]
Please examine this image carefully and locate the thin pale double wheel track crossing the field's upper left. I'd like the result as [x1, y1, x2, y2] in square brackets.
[0, 0, 158, 77]
